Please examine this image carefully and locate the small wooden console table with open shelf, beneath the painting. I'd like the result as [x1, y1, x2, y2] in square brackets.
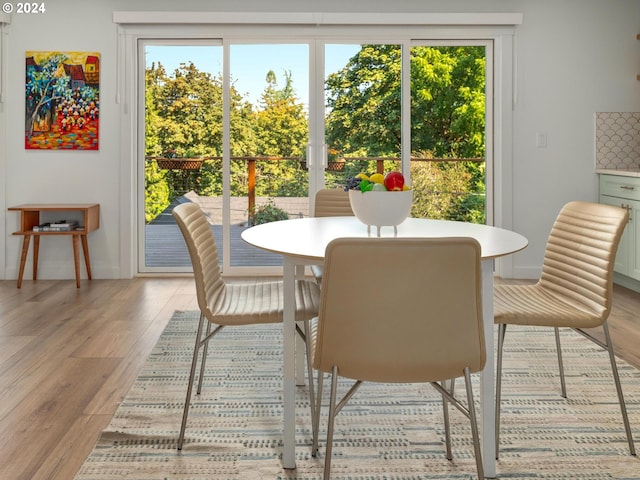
[9, 203, 100, 288]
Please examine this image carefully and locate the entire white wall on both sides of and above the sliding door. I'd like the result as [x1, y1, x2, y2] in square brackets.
[0, 0, 640, 279]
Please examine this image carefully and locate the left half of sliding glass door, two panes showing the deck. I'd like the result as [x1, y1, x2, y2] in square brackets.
[139, 41, 317, 272]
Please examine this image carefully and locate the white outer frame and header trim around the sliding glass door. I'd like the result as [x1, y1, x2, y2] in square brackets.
[114, 12, 522, 277]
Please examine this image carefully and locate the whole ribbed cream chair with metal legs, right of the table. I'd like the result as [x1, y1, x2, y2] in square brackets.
[494, 202, 636, 458]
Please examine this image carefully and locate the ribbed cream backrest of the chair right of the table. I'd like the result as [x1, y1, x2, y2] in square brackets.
[539, 202, 629, 326]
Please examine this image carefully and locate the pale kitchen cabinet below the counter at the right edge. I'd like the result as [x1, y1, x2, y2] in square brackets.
[600, 174, 640, 280]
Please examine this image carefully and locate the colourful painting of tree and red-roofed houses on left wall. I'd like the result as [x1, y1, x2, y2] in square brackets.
[24, 51, 100, 150]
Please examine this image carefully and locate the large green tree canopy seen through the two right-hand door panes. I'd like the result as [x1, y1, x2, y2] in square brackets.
[326, 45, 485, 158]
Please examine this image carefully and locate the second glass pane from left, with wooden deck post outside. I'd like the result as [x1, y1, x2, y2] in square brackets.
[230, 44, 309, 266]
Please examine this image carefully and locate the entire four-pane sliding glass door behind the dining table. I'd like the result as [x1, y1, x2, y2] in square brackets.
[139, 36, 492, 274]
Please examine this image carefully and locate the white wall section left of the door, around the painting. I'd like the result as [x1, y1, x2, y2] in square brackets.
[0, 0, 120, 279]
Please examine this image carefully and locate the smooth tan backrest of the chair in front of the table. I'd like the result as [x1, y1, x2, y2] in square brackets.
[314, 238, 485, 382]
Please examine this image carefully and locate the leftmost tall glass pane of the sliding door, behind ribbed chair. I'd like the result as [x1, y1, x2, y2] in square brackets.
[144, 45, 223, 271]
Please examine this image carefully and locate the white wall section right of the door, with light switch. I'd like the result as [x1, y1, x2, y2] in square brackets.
[513, 0, 640, 277]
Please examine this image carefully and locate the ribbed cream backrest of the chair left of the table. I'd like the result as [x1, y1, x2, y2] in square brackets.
[172, 203, 225, 318]
